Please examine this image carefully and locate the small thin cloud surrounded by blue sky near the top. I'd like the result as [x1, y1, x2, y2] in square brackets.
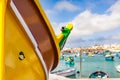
[55, 1, 79, 11]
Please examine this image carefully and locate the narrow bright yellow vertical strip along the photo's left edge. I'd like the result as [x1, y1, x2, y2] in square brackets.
[0, 0, 5, 80]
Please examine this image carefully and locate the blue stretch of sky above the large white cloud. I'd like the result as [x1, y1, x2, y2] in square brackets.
[40, 0, 116, 23]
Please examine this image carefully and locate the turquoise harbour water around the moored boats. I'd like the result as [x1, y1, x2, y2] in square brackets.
[54, 55, 120, 78]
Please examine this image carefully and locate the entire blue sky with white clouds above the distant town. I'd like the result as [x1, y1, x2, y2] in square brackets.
[40, 0, 120, 48]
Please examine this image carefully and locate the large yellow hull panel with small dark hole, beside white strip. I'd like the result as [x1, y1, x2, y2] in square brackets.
[4, 2, 46, 80]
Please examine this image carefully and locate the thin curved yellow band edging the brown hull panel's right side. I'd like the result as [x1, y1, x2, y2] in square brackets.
[34, 0, 60, 59]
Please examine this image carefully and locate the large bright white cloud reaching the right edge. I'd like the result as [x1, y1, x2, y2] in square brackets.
[71, 1, 120, 37]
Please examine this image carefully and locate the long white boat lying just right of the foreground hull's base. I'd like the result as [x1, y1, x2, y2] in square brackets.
[51, 68, 76, 76]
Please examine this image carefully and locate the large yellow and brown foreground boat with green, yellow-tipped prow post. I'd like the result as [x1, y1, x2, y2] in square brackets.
[0, 0, 73, 80]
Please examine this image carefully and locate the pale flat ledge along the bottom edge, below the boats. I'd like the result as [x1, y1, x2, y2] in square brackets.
[49, 74, 120, 80]
